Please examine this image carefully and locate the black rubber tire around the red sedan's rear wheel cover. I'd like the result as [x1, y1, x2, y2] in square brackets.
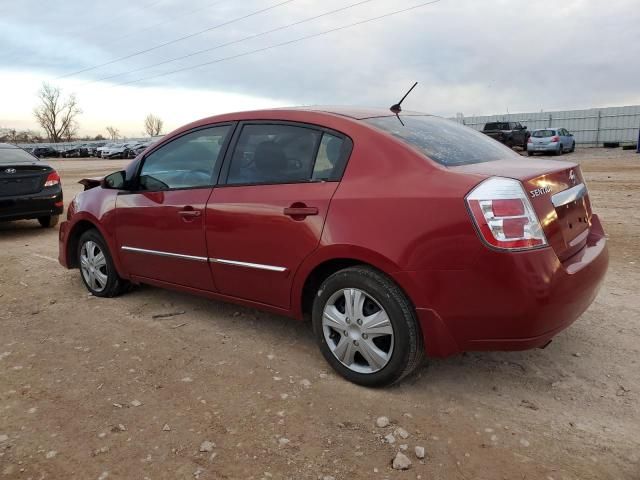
[312, 266, 424, 387]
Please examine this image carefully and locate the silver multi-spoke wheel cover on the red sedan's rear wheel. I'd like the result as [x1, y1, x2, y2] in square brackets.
[322, 288, 394, 373]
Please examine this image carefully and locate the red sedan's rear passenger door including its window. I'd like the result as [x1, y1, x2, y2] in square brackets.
[206, 122, 352, 308]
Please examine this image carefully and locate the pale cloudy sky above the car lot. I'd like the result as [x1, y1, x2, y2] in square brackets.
[0, 0, 640, 136]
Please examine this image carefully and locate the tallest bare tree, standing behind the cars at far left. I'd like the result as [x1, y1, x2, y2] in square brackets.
[33, 83, 82, 143]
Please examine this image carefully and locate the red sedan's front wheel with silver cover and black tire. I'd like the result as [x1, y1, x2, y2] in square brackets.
[77, 230, 128, 297]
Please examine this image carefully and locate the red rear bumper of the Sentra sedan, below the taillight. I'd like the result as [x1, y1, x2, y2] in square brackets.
[403, 215, 609, 356]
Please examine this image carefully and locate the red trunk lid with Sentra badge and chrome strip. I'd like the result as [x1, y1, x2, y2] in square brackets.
[450, 158, 592, 261]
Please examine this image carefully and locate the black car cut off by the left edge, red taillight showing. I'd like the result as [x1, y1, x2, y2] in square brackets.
[0, 143, 63, 227]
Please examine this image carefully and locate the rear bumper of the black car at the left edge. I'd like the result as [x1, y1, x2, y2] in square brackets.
[0, 186, 64, 221]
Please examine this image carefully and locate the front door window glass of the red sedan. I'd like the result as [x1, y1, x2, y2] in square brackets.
[139, 125, 231, 191]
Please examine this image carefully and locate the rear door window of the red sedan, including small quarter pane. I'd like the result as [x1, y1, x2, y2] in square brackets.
[227, 124, 344, 185]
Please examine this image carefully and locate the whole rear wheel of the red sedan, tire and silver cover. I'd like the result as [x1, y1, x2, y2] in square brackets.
[312, 266, 424, 387]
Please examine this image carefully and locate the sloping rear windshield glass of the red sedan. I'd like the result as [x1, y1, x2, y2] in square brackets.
[365, 115, 519, 167]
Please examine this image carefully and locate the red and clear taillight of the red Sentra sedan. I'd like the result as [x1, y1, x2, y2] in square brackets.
[466, 177, 547, 250]
